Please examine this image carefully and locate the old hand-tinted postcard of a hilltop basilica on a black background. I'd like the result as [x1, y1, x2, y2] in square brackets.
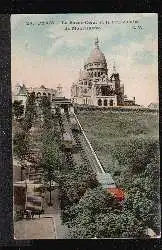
[11, 13, 161, 240]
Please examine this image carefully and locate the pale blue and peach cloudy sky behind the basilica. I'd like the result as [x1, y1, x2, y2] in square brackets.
[11, 13, 158, 105]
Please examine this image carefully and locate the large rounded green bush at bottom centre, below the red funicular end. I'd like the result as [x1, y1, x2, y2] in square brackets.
[66, 187, 145, 239]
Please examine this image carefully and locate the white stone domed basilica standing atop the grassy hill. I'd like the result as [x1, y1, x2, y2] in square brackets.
[71, 38, 135, 107]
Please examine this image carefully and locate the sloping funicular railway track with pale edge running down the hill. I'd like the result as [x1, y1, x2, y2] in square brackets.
[58, 108, 108, 176]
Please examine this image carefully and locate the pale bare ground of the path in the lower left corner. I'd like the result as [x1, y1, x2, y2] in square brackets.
[14, 189, 68, 240]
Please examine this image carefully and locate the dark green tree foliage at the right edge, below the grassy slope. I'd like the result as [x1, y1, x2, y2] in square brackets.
[123, 154, 160, 234]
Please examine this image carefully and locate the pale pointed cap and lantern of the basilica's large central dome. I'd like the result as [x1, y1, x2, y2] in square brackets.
[87, 38, 106, 64]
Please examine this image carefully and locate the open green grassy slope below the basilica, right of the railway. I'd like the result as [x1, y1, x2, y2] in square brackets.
[78, 110, 159, 178]
